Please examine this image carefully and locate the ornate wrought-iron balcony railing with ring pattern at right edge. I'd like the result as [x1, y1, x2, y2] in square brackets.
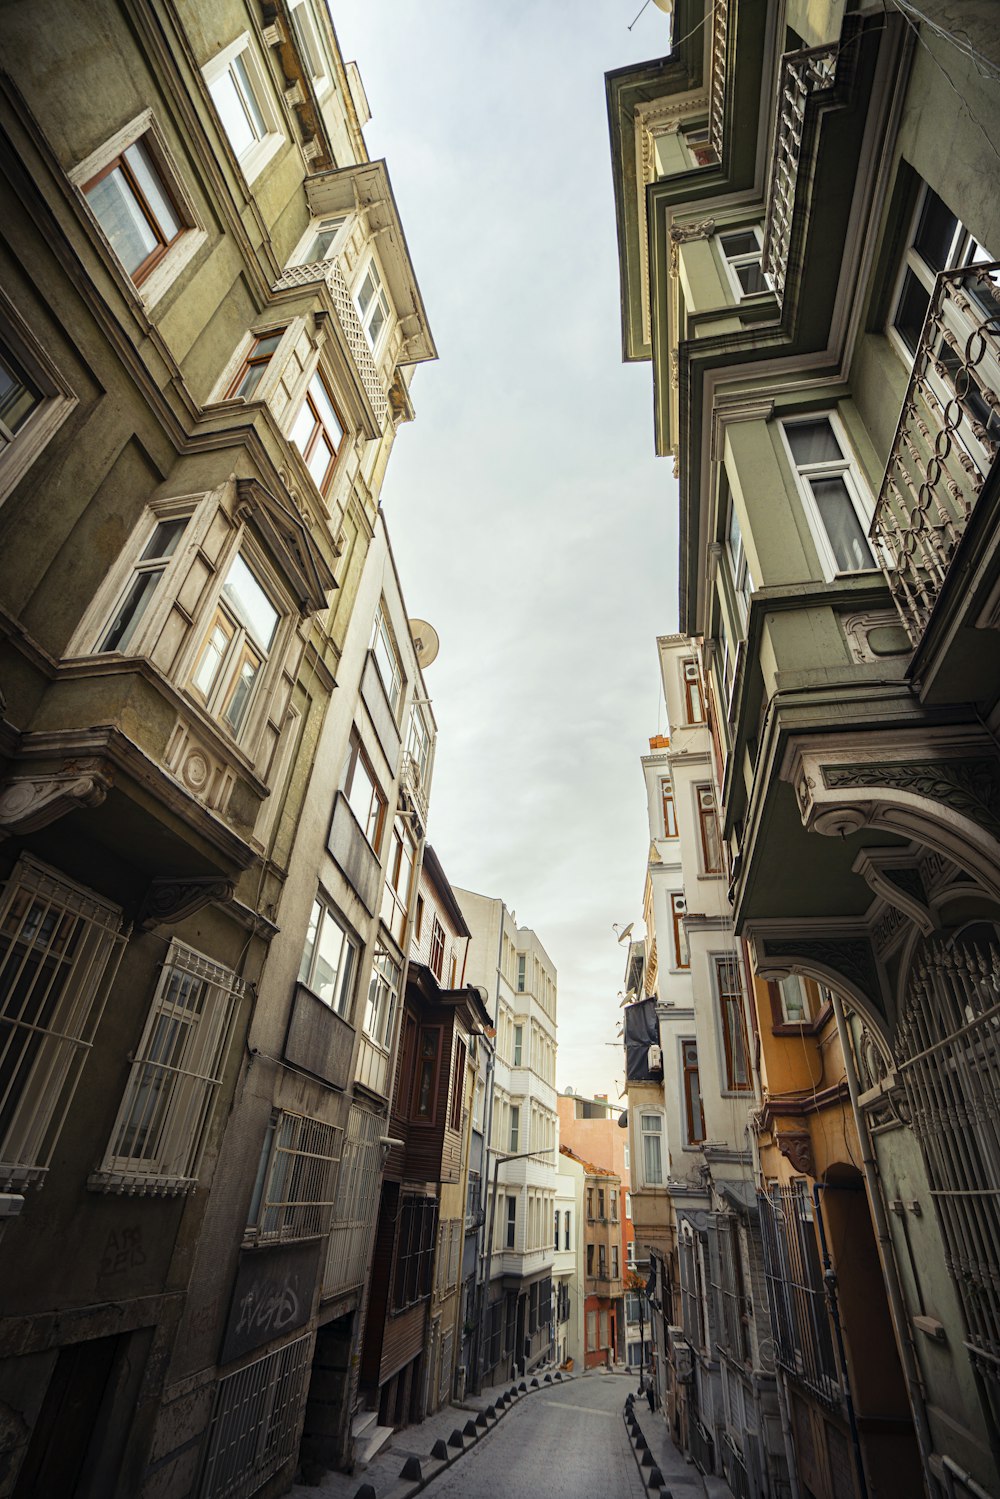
[871, 261, 1000, 645]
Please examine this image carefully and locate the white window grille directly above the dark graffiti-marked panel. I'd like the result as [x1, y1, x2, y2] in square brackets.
[249, 1112, 343, 1244]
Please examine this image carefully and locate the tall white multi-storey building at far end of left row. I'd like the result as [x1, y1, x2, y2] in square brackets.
[454, 886, 558, 1382]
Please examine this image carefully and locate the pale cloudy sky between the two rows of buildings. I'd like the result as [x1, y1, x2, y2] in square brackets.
[331, 0, 678, 1096]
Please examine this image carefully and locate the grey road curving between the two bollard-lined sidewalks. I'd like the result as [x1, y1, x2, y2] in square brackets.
[424, 1375, 645, 1499]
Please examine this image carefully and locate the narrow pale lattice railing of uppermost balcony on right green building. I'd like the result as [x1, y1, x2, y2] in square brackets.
[760, 46, 837, 298]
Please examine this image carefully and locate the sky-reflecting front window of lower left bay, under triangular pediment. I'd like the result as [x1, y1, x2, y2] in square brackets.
[192, 552, 279, 735]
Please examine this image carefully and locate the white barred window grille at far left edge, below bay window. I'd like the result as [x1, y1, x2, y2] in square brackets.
[0, 856, 124, 1192]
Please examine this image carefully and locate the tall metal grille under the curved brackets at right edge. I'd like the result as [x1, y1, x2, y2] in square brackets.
[898, 926, 1000, 1399]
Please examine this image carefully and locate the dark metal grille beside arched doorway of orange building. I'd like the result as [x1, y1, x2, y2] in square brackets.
[759, 1180, 841, 1406]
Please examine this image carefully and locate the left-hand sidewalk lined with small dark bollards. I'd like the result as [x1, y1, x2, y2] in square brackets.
[291, 1370, 578, 1499]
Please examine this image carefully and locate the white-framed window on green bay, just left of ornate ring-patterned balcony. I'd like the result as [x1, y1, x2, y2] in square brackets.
[781, 415, 876, 580]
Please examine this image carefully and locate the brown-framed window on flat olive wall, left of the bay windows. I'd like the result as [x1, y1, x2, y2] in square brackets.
[81, 132, 186, 286]
